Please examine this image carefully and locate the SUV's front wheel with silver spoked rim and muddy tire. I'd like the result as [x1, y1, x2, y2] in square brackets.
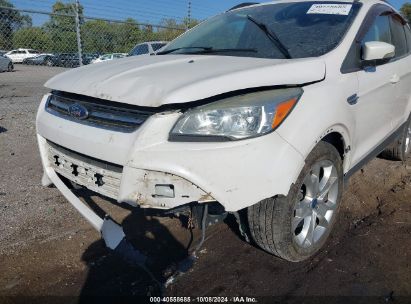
[247, 142, 343, 262]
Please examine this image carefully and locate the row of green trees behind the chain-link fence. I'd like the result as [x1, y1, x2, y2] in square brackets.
[0, 0, 192, 54]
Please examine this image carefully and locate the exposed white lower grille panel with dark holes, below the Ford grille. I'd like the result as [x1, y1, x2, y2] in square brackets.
[47, 142, 123, 199]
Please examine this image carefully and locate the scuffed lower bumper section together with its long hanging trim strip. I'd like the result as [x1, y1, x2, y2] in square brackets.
[37, 135, 214, 252]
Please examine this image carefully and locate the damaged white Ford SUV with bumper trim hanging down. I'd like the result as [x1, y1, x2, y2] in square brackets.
[37, 0, 411, 261]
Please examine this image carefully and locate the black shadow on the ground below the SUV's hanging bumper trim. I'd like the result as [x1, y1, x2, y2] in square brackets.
[76, 190, 196, 303]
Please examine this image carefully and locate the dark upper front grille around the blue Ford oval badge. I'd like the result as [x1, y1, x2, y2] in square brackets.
[46, 92, 156, 132]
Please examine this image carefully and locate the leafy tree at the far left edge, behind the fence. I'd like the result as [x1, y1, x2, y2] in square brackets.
[0, 0, 32, 50]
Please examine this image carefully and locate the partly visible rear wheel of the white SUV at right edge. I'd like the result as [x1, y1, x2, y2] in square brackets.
[380, 116, 411, 161]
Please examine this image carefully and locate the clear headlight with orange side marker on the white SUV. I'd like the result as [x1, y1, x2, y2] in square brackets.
[170, 88, 303, 141]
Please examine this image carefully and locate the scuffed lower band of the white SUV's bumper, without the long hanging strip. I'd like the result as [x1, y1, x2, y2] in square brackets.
[38, 135, 215, 209]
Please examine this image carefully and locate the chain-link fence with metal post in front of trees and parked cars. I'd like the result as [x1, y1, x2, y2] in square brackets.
[0, 3, 186, 67]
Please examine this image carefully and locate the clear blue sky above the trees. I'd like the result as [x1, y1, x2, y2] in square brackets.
[9, 0, 411, 25]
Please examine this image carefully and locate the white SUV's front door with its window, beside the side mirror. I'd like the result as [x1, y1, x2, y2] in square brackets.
[352, 11, 398, 164]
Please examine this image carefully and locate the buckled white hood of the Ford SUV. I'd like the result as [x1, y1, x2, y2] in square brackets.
[45, 55, 326, 107]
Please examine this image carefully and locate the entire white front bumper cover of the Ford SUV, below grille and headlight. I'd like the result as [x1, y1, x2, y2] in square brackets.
[37, 92, 304, 216]
